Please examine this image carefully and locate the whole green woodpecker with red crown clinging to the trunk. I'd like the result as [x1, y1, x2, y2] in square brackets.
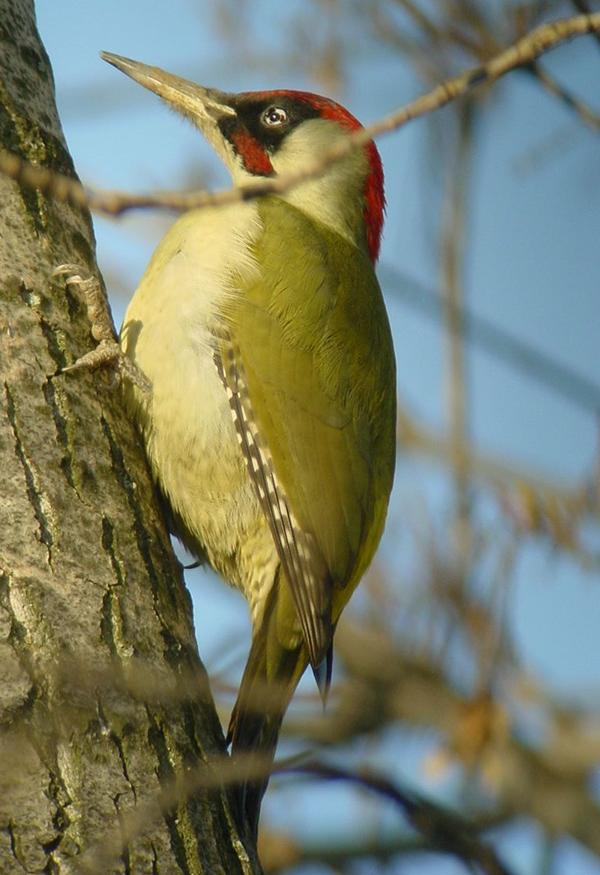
[103, 54, 395, 832]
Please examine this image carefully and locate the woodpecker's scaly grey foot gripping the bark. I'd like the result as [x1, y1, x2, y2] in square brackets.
[52, 264, 152, 392]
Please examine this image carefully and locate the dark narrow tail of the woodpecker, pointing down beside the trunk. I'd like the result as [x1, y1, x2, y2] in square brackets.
[227, 579, 308, 839]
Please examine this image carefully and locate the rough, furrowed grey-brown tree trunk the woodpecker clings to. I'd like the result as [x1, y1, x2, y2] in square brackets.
[0, 0, 258, 875]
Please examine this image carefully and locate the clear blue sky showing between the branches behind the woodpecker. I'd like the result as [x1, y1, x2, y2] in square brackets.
[37, 0, 600, 875]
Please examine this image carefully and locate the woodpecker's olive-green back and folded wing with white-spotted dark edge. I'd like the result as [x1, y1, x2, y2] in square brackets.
[221, 198, 396, 666]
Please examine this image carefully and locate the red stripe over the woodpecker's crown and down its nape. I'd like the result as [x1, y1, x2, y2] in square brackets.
[255, 90, 385, 262]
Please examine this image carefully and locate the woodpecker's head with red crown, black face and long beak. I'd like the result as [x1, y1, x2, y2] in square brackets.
[102, 52, 385, 261]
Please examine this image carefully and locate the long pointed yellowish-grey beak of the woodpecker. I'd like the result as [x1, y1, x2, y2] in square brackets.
[100, 52, 237, 169]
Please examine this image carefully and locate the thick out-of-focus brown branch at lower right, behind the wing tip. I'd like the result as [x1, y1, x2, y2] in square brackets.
[296, 622, 600, 854]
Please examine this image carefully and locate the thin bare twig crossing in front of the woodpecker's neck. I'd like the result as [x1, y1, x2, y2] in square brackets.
[0, 13, 600, 215]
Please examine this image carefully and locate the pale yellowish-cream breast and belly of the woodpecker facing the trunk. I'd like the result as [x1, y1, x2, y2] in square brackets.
[121, 204, 261, 583]
